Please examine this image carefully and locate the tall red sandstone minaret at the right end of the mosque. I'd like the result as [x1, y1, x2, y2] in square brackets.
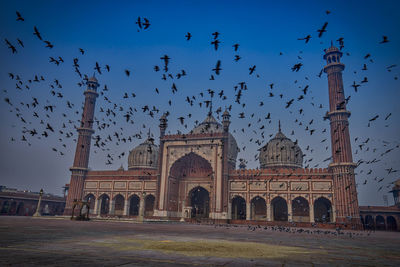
[324, 45, 361, 228]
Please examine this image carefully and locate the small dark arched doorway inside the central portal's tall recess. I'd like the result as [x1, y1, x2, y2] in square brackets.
[189, 186, 210, 218]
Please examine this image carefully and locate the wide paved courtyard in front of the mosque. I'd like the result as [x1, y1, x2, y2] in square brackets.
[0, 216, 400, 266]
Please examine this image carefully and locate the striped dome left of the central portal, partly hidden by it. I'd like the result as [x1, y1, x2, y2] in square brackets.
[128, 138, 158, 170]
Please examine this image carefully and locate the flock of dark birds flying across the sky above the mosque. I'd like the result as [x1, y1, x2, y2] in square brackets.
[3, 9, 400, 198]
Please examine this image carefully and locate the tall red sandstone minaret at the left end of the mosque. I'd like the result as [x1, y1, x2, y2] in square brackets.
[64, 76, 99, 215]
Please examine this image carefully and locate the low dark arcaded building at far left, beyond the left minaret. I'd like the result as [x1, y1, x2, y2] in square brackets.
[0, 186, 65, 216]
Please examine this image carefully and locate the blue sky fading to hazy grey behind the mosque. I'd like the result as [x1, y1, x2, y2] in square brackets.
[0, 1, 400, 205]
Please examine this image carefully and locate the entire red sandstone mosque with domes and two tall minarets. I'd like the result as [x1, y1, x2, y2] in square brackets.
[65, 47, 388, 229]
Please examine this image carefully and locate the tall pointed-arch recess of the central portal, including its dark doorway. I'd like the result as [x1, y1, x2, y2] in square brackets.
[167, 152, 213, 218]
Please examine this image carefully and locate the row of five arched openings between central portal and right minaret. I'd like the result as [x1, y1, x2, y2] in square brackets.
[228, 195, 335, 223]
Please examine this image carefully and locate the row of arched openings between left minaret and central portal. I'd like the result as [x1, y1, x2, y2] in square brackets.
[84, 193, 155, 217]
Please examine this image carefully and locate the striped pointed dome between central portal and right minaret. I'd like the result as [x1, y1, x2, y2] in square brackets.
[259, 126, 303, 169]
